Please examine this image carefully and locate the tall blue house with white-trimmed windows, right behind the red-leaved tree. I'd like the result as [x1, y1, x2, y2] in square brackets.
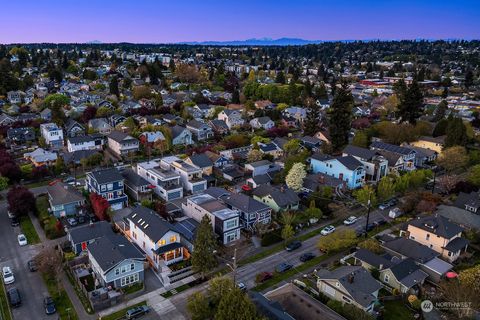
[85, 168, 128, 210]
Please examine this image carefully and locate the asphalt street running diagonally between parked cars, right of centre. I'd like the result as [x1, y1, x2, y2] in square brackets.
[236, 209, 390, 289]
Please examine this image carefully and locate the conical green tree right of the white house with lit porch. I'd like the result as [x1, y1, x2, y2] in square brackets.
[192, 215, 217, 278]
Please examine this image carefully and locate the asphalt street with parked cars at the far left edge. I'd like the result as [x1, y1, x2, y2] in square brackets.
[0, 201, 52, 320]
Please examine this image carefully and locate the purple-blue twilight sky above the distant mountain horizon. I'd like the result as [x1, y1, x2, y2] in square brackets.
[0, 0, 480, 43]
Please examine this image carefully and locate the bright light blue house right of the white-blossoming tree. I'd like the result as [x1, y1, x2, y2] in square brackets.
[310, 153, 365, 189]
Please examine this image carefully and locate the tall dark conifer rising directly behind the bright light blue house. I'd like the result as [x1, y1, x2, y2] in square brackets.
[329, 86, 354, 151]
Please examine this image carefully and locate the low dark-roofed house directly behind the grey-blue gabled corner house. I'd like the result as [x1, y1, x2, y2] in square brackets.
[67, 221, 113, 255]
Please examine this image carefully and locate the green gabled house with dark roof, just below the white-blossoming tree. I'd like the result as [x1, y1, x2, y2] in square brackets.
[253, 184, 300, 212]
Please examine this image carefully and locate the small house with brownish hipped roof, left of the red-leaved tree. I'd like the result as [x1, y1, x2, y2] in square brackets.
[47, 182, 85, 218]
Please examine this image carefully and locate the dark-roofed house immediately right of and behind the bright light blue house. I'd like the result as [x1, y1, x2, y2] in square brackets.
[342, 145, 388, 182]
